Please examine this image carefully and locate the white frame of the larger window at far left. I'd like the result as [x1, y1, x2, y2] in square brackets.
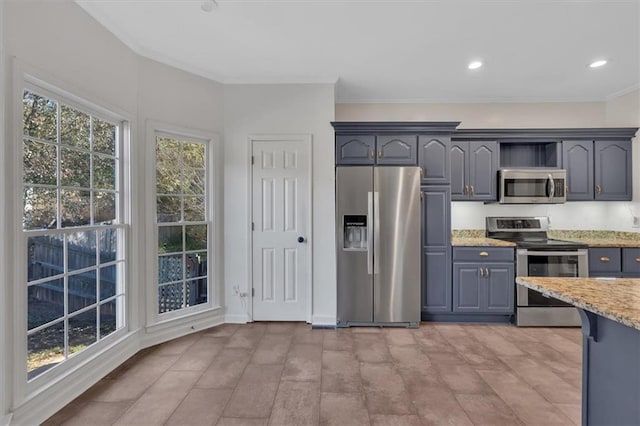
[8, 69, 135, 407]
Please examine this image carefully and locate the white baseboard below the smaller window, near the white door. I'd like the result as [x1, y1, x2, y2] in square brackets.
[140, 308, 225, 349]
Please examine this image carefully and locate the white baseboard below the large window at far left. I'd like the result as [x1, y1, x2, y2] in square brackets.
[10, 333, 140, 425]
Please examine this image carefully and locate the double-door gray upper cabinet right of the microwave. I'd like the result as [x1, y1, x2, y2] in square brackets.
[562, 140, 632, 201]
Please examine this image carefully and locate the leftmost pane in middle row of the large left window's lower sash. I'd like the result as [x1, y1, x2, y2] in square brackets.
[27, 278, 64, 330]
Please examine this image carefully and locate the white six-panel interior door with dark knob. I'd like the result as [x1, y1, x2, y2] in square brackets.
[251, 138, 311, 321]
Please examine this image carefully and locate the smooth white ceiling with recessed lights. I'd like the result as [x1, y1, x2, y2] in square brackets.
[77, 0, 640, 102]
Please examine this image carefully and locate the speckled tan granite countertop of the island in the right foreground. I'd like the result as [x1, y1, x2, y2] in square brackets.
[516, 277, 640, 330]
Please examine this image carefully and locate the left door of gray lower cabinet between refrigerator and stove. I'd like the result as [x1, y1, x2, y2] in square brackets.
[453, 263, 483, 313]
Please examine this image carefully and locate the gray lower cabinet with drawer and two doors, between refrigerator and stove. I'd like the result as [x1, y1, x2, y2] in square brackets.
[452, 247, 515, 315]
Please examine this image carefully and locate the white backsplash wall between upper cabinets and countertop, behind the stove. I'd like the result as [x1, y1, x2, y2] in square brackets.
[451, 201, 640, 233]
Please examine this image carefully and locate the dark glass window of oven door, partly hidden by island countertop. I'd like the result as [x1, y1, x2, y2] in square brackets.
[527, 256, 578, 307]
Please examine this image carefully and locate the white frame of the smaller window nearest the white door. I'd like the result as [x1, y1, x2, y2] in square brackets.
[145, 120, 223, 326]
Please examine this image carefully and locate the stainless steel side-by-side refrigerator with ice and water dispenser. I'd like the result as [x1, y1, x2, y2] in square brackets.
[336, 166, 421, 327]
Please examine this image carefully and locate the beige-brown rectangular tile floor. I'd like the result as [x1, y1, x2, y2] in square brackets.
[45, 323, 582, 426]
